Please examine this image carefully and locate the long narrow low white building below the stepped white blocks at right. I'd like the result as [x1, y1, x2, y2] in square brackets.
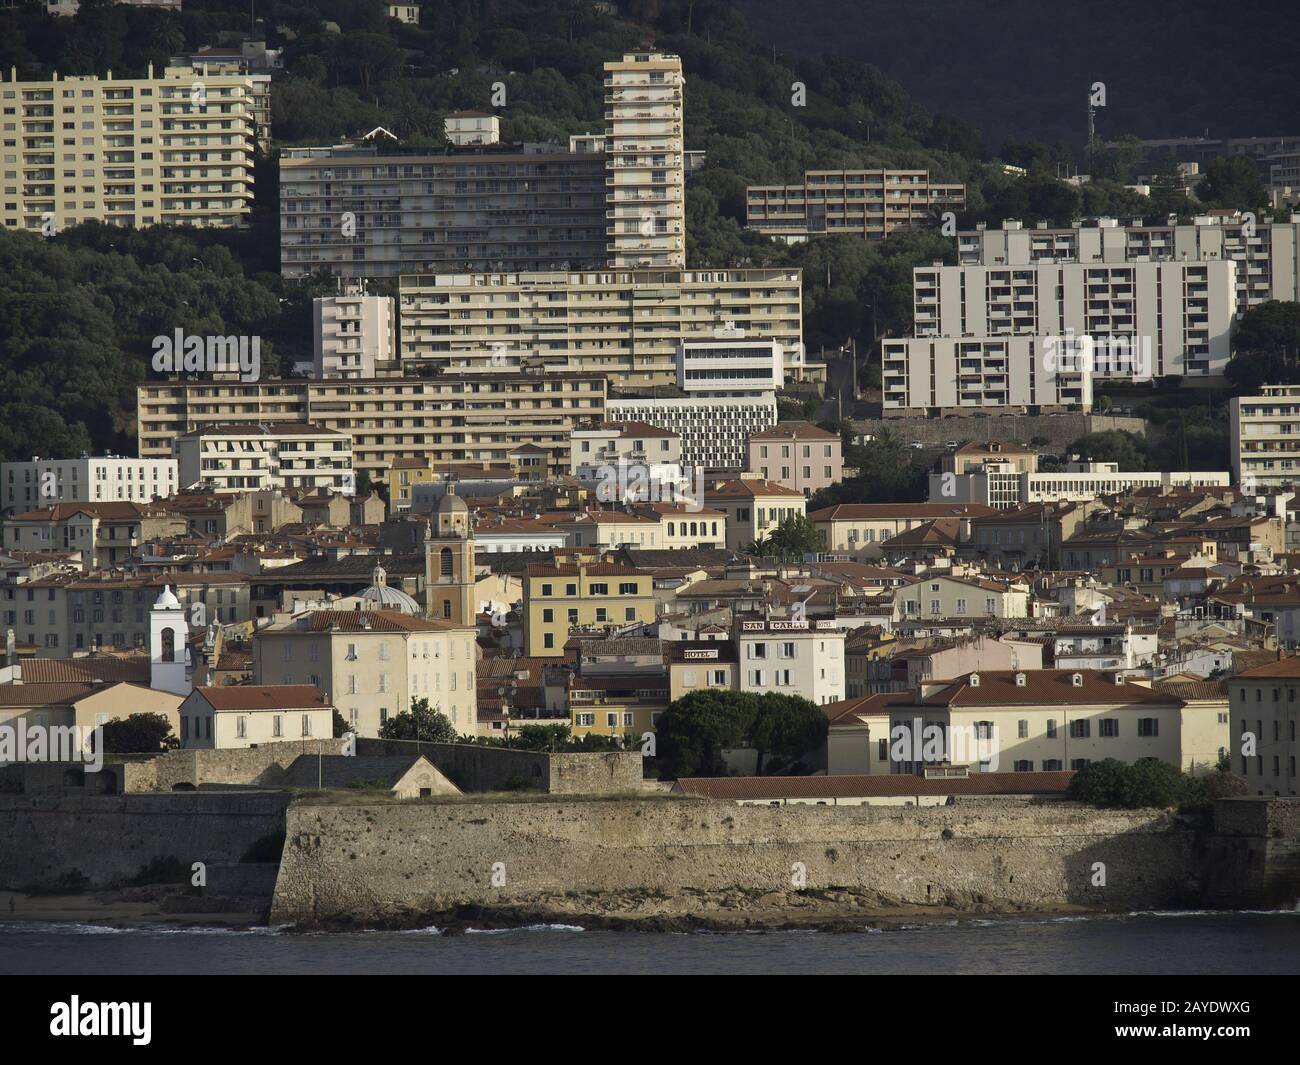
[930, 462, 1232, 507]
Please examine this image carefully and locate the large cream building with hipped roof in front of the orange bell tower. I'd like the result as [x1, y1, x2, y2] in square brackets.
[254, 610, 478, 736]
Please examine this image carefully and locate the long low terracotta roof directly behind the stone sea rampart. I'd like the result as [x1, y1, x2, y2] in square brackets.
[675, 771, 1074, 800]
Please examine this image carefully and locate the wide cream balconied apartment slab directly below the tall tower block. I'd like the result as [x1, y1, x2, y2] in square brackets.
[398, 269, 806, 389]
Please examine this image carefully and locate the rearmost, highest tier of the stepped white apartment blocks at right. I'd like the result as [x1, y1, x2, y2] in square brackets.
[957, 214, 1300, 312]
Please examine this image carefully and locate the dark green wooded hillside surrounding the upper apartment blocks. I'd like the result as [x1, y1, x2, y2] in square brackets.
[0, 0, 1284, 458]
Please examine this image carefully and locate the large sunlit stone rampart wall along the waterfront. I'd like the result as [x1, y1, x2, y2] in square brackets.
[272, 798, 1201, 925]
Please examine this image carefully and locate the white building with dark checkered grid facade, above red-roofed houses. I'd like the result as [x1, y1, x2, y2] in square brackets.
[605, 391, 776, 469]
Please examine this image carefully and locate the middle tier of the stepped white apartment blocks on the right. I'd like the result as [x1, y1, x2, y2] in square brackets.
[913, 259, 1236, 378]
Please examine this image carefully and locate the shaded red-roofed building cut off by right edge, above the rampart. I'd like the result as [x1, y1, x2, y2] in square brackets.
[1227, 655, 1300, 795]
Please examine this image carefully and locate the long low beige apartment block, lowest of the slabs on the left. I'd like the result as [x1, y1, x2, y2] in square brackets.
[137, 371, 607, 480]
